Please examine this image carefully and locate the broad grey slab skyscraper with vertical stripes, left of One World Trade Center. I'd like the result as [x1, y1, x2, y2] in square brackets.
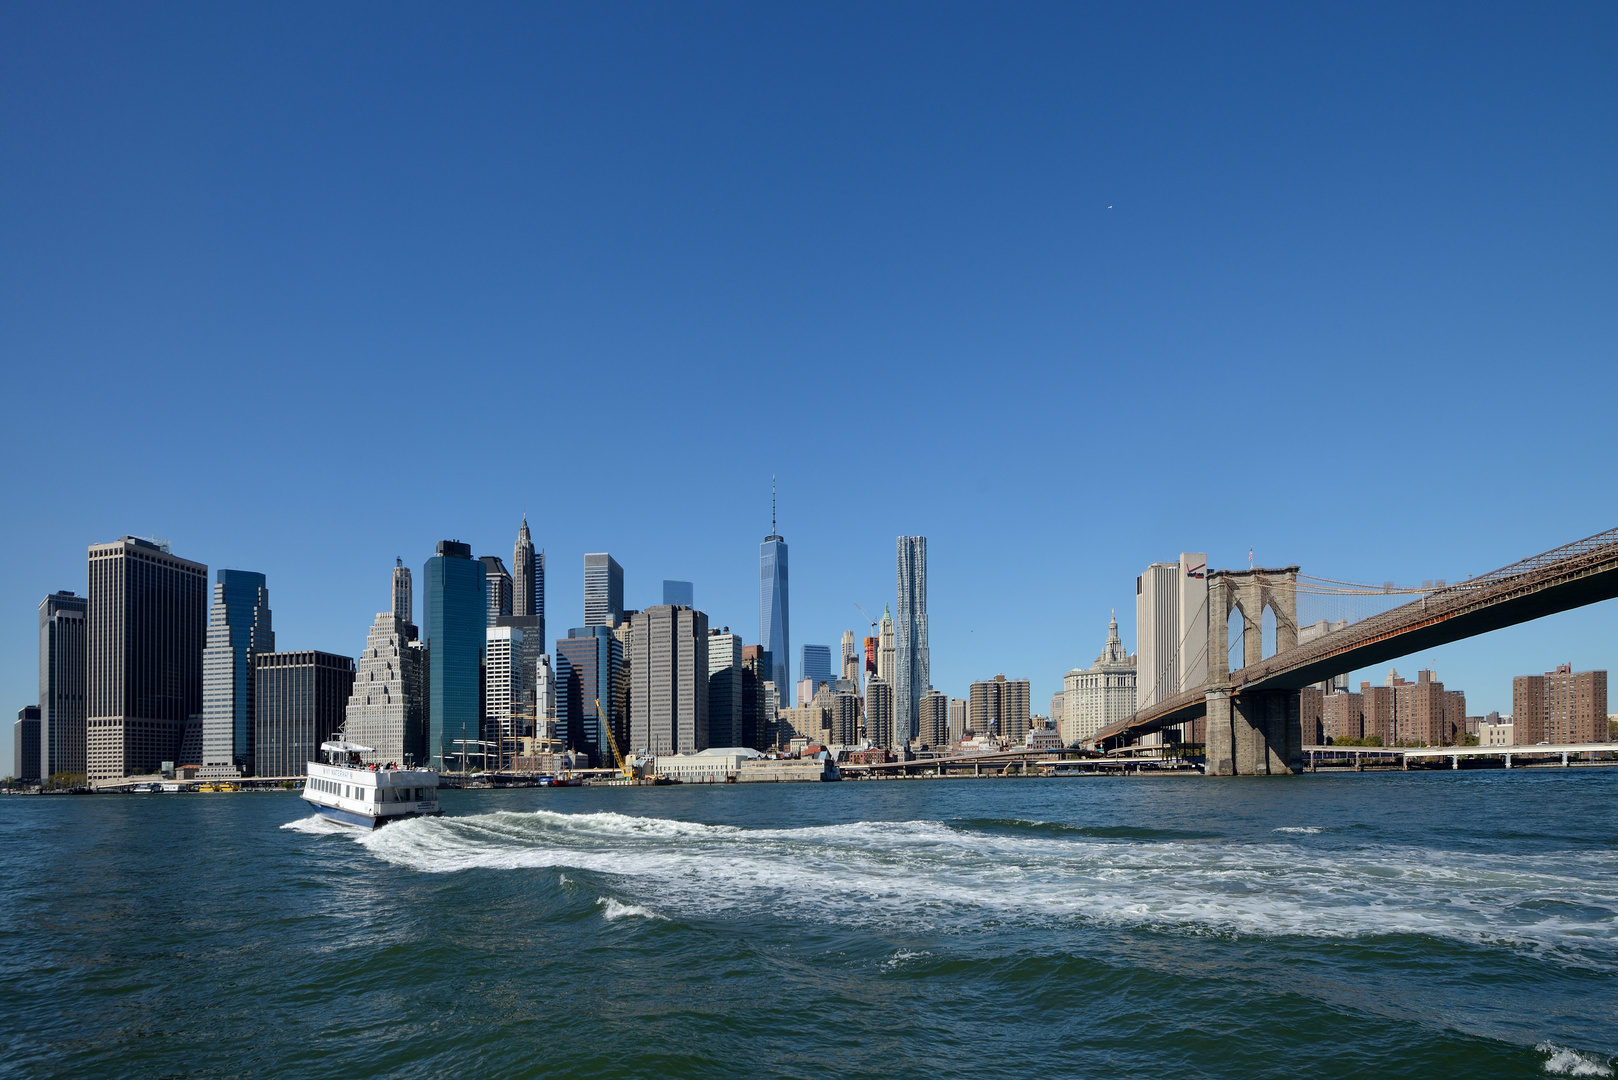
[629, 604, 709, 755]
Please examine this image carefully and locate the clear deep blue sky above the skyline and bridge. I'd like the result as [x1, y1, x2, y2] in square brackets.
[0, 3, 1618, 771]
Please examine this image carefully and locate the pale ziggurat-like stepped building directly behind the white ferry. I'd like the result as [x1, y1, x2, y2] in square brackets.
[343, 610, 427, 766]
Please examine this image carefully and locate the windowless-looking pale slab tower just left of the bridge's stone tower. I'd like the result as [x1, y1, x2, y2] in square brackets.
[1134, 552, 1209, 709]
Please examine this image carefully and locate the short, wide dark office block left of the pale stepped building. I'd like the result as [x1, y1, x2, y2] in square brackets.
[252, 651, 355, 776]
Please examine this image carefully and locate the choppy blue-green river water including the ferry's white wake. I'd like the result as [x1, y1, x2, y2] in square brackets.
[0, 769, 1618, 1078]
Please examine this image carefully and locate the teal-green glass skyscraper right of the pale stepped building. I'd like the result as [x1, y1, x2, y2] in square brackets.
[421, 541, 489, 769]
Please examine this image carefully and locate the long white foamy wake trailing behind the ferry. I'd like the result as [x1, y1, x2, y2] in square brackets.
[315, 810, 1618, 968]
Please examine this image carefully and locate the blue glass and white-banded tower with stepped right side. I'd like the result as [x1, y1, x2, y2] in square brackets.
[202, 570, 275, 777]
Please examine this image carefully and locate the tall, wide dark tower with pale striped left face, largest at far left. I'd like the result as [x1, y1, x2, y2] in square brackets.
[84, 536, 209, 780]
